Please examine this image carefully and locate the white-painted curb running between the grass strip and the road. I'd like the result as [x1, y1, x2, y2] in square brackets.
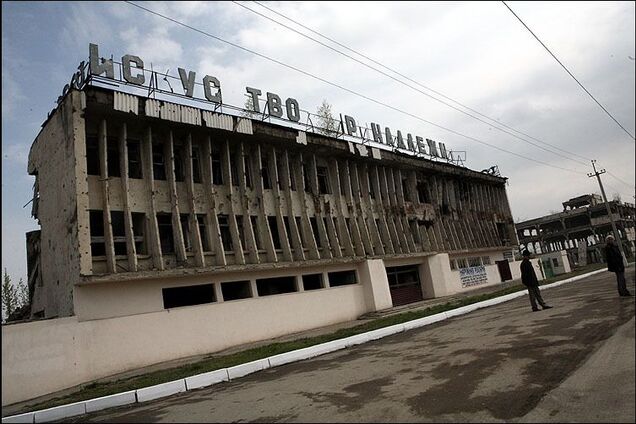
[2, 269, 606, 424]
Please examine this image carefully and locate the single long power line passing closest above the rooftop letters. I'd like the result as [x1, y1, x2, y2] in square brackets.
[125, 0, 585, 174]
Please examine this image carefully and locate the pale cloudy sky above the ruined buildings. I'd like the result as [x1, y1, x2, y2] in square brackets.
[2, 1, 636, 281]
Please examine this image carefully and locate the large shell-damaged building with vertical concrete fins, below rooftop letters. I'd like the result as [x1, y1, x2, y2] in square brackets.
[28, 86, 517, 319]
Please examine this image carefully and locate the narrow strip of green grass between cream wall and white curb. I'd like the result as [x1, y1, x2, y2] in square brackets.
[16, 264, 606, 414]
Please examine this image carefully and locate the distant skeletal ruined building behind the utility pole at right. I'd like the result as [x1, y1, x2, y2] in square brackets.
[516, 194, 636, 263]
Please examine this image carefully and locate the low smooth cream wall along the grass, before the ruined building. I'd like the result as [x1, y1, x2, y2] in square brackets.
[2, 284, 368, 405]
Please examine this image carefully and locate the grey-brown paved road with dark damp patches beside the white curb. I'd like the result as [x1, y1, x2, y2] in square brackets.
[67, 268, 636, 422]
